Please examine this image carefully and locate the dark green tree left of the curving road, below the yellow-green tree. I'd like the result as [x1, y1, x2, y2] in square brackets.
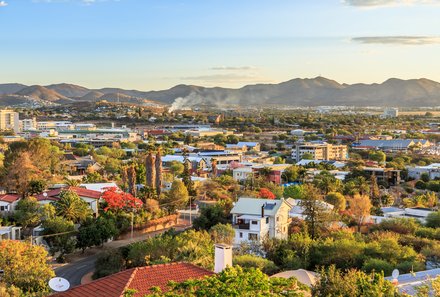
[43, 217, 76, 263]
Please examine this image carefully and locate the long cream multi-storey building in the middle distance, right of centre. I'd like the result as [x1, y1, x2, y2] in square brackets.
[292, 142, 348, 162]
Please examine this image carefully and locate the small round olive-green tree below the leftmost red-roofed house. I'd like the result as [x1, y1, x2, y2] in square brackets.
[13, 197, 41, 229]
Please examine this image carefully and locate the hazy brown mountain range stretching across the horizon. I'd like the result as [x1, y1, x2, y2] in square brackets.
[0, 77, 440, 109]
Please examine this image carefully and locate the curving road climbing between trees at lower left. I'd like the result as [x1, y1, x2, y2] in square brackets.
[55, 225, 189, 287]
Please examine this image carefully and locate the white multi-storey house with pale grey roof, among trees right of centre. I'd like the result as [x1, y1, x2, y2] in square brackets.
[231, 197, 292, 245]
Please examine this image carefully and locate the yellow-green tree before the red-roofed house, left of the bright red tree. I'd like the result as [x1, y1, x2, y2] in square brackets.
[53, 190, 92, 223]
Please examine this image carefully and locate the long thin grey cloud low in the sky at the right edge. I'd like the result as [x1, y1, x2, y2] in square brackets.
[351, 36, 440, 45]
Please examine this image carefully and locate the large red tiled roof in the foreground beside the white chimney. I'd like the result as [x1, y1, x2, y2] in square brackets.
[54, 263, 214, 297]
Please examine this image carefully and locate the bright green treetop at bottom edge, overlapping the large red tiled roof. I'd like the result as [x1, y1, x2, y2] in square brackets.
[147, 266, 308, 297]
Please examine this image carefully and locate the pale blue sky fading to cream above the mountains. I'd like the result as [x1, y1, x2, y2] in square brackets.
[0, 0, 440, 90]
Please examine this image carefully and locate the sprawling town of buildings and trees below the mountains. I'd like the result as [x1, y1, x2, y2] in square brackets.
[0, 102, 440, 296]
